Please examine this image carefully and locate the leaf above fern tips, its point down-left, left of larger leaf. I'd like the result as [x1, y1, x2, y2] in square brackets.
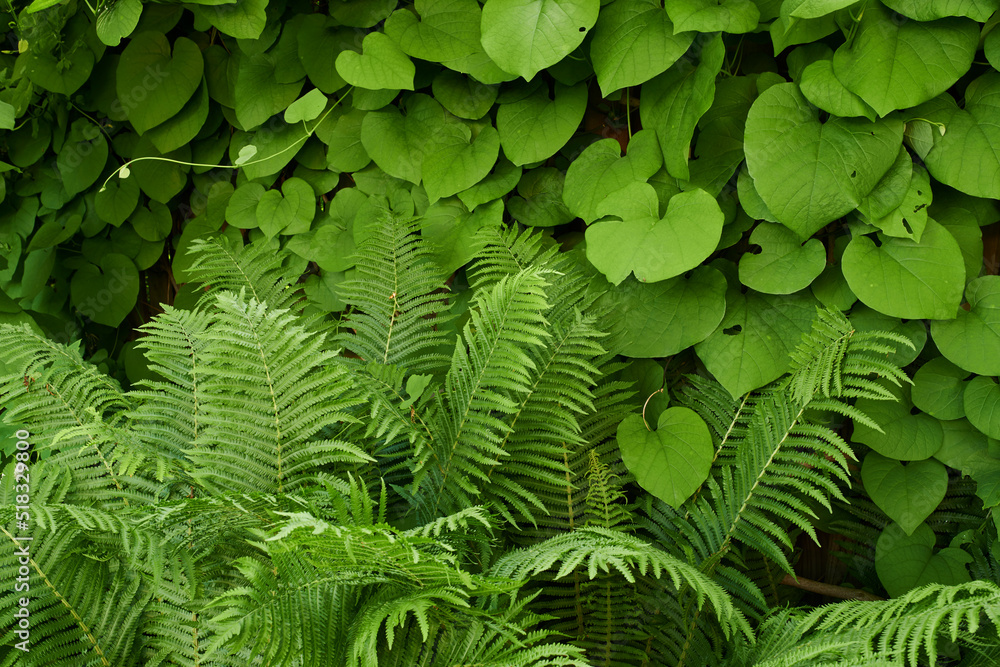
[422, 125, 500, 202]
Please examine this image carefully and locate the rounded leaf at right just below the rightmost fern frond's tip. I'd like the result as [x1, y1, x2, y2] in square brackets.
[853, 385, 944, 461]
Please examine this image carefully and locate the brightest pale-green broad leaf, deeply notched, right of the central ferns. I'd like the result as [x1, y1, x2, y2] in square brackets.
[587, 183, 725, 285]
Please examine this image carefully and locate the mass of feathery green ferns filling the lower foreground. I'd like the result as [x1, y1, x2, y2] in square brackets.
[0, 205, 1000, 667]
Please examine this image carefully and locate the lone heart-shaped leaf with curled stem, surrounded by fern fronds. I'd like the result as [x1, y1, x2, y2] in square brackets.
[618, 408, 714, 508]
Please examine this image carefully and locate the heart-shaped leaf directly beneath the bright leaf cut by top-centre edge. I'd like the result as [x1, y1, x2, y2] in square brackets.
[497, 83, 587, 166]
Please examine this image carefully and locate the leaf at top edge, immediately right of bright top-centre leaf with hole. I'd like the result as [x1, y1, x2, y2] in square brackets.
[590, 0, 692, 96]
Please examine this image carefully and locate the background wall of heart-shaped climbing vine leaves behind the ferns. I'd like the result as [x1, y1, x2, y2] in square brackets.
[0, 0, 1000, 594]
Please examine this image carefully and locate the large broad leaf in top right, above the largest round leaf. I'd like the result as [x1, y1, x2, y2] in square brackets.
[833, 2, 979, 116]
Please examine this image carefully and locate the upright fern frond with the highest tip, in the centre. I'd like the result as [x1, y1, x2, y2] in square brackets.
[337, 204, 448, 373]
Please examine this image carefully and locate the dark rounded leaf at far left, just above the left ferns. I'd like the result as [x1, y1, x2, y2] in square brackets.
[70, 253, 139, 327]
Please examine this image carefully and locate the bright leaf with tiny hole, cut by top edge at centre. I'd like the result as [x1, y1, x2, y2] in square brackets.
[482, 0, 601, 81]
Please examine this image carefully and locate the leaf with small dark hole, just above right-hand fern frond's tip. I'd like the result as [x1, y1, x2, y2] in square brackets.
[694, 286, 817, 398]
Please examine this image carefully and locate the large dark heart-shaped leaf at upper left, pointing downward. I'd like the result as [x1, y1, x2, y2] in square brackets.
[116, 30, 205, 134]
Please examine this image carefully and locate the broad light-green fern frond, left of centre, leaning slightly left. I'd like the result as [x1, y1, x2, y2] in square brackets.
[187, 293, 371, 493]
